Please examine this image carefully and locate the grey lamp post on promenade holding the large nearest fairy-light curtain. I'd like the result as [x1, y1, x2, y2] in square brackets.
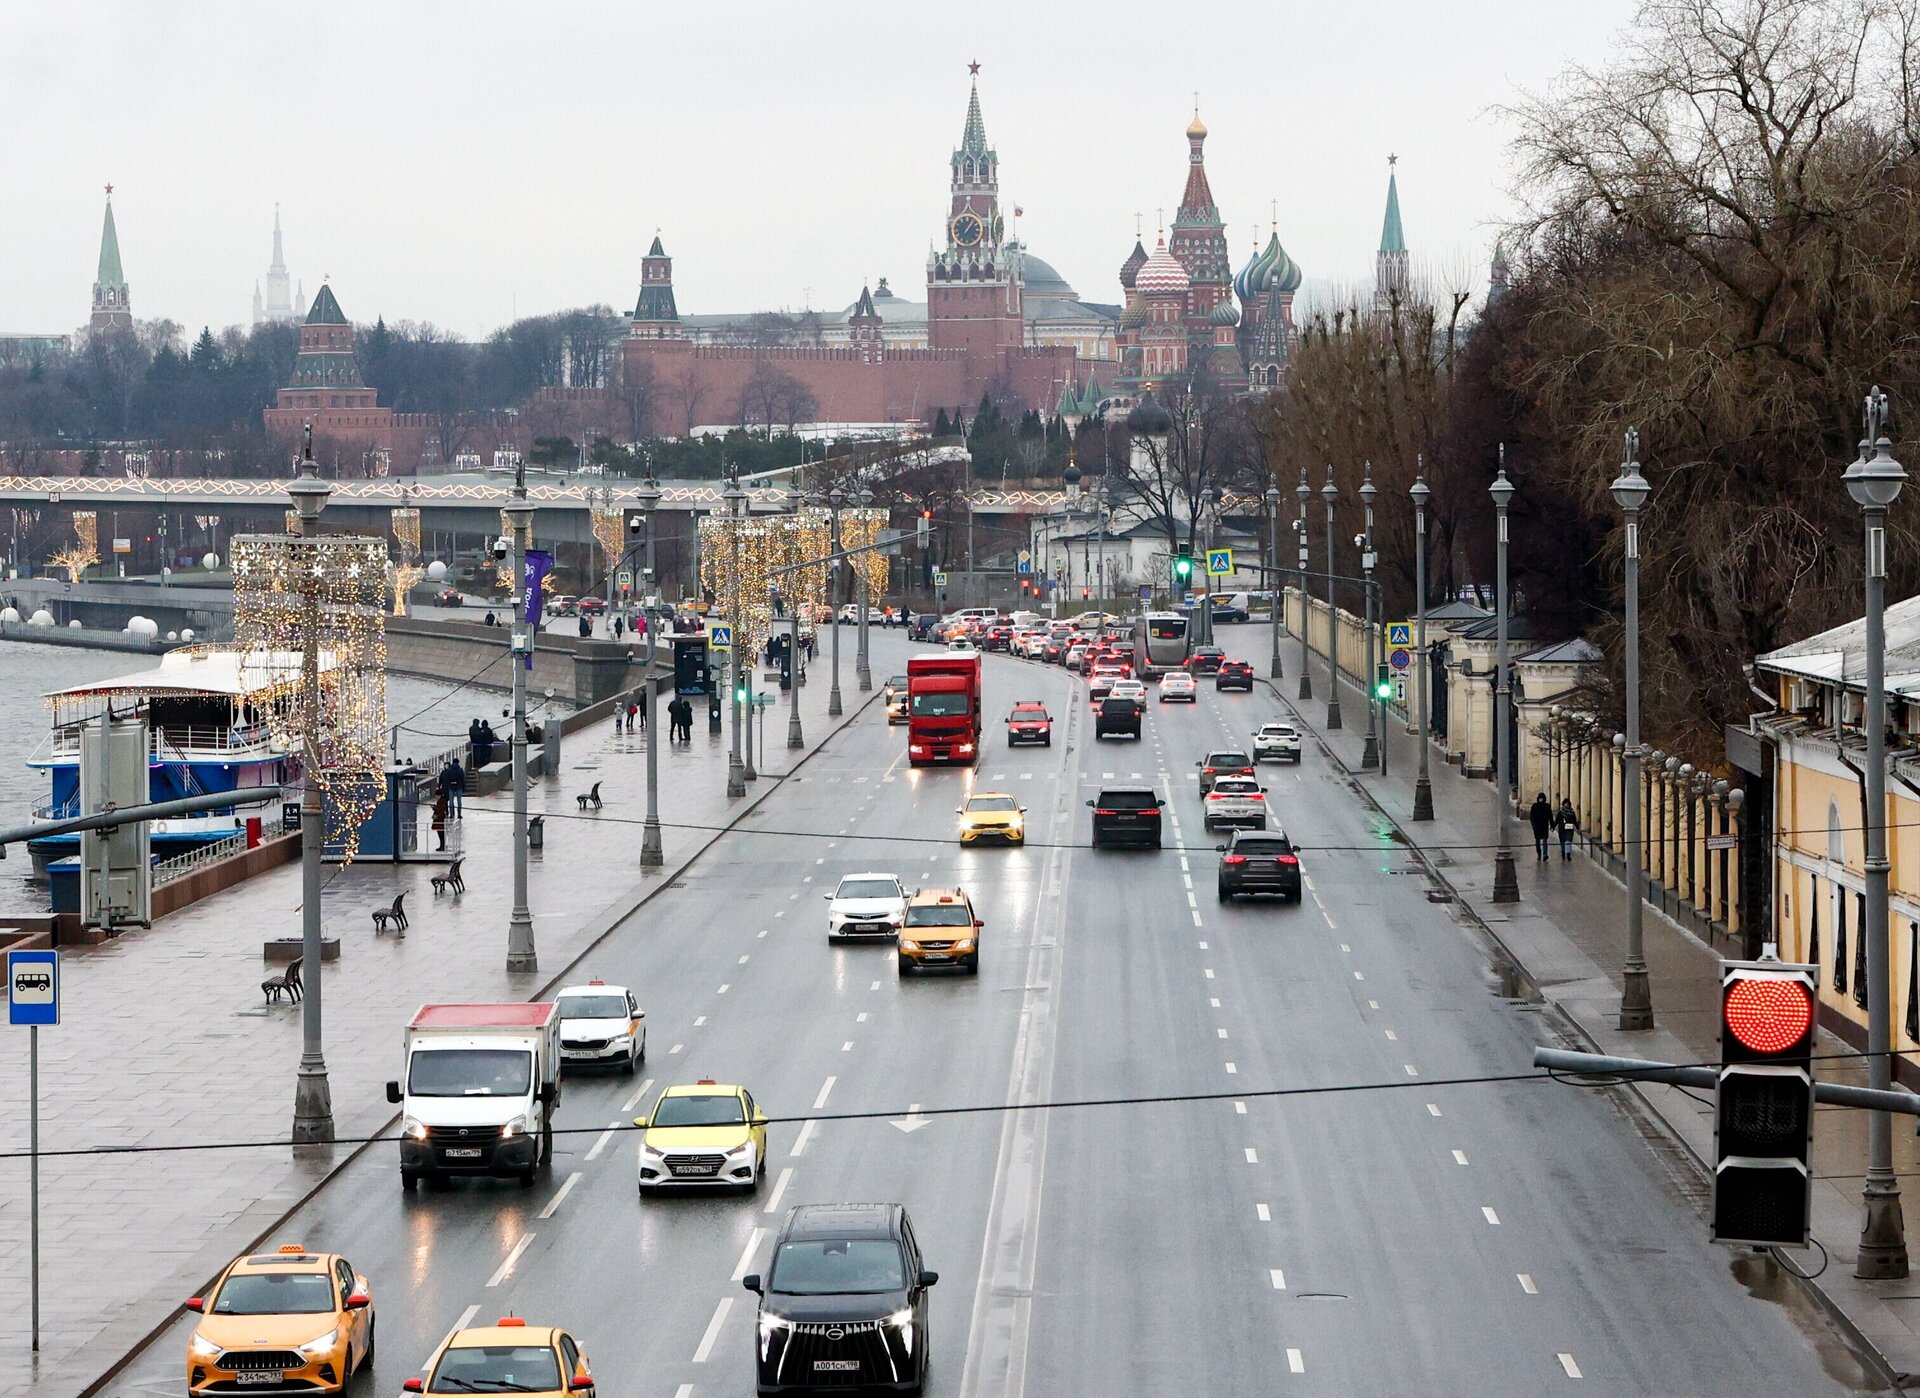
[286, 422, 334, 1141]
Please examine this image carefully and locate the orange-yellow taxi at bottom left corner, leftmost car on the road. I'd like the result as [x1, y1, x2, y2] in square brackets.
[186, 1242, 372, 1398]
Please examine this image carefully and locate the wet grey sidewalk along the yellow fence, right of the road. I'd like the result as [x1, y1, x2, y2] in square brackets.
[1261, 639, 1920, 1375]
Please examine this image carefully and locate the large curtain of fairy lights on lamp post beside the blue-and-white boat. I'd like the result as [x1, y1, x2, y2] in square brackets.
[228, 534, 388, 862]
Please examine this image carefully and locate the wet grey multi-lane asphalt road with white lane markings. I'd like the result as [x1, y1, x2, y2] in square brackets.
[106, 628, 1872, 1398]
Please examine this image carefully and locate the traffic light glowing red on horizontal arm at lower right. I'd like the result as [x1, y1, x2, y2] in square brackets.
[1713, 962, 1818, 1248]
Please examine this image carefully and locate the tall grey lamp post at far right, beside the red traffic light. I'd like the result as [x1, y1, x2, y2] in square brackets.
[1845, 386, 1907, 1277]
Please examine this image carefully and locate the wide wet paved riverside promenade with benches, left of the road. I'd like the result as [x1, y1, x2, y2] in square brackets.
[0, 636, 893, 1394]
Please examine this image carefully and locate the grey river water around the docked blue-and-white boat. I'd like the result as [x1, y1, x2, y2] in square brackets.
[0, 641, 568, 914]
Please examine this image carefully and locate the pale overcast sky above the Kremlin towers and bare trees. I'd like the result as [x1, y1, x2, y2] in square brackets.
[0, 0, 1634, 336]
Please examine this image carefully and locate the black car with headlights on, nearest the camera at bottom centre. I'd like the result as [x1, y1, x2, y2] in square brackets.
[741, 1204, 941, 1394]
